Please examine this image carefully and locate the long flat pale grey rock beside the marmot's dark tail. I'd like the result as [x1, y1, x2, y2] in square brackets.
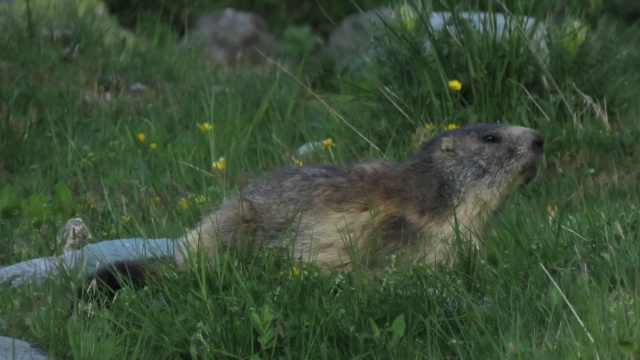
[0, 238, 174, 286]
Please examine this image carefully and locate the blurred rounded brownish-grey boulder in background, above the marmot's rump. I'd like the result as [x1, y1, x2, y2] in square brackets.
[182, 8, 276, 67]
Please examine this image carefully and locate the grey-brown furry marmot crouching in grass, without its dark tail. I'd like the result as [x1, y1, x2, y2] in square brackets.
[175, 124, 544, 270]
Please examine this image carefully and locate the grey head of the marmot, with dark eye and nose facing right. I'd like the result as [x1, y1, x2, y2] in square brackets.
[412, 124, 544, 193]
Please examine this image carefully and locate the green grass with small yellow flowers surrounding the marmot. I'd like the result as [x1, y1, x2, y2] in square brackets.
[0, 1, 640, 359]
